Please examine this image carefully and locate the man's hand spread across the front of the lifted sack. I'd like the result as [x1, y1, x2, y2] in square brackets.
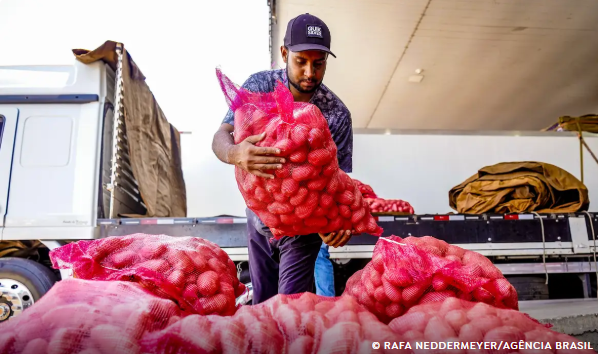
[228, 133, 285, 178]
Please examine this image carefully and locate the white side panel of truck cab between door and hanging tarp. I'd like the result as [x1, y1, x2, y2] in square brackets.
[5, 103, 100, 228]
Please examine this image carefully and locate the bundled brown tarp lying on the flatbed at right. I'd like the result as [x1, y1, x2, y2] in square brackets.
[449, 161, 590, 214]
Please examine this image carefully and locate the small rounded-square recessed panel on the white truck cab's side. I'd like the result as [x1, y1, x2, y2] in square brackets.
[20, 115, 73, 167]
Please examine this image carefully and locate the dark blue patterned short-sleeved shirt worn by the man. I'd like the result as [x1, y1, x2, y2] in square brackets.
[222, 69, 353, 173]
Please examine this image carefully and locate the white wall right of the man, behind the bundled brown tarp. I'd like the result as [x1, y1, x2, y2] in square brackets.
[352, 133, 598, 214]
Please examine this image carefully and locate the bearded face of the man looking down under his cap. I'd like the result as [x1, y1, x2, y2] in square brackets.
[282, 47, 328, 93]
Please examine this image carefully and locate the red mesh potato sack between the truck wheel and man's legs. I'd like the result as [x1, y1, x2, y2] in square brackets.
[50, 234, 245, 316]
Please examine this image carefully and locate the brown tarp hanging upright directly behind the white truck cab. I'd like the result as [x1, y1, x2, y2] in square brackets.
[73, 41, 187, 217]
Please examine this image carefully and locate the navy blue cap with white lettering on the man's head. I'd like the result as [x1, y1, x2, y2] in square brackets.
[284, 14, 336, 58]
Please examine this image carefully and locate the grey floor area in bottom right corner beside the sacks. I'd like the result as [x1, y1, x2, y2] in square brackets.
[519, 299, 598, 352]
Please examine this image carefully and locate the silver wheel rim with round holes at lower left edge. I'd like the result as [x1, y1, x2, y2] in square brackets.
[0, 279, 35, 322]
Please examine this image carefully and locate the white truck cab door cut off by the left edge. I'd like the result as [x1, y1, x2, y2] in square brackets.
[0, 106, 19, 231]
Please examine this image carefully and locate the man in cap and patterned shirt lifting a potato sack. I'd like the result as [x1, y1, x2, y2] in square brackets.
[212, 14, 353, 304]
